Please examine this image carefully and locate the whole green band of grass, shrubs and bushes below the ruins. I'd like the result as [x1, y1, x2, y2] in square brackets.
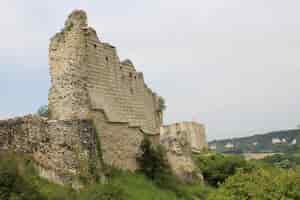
[0, 146, 300, 200]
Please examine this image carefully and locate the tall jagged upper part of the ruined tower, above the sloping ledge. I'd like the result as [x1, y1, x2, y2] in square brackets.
[49, 10, 162, 134]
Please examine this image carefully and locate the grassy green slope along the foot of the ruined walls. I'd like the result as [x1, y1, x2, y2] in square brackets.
[0, 154, 207, 200]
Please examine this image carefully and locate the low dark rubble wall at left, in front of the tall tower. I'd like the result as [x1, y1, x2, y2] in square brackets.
[0, 115, 101, 186]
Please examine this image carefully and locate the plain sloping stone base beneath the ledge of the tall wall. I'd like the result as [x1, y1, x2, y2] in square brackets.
[93, 111, 145, 171]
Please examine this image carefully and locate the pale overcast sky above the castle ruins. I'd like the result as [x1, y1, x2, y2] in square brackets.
[0, 0, 300, 140]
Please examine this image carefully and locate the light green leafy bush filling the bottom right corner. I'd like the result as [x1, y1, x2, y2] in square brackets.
[208, 168, 300, 200]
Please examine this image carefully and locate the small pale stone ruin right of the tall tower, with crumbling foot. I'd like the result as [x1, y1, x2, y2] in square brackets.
[160, 122, 207, 181]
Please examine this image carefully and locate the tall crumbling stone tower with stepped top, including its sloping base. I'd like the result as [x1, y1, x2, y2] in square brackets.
[49, 10, 162, 170]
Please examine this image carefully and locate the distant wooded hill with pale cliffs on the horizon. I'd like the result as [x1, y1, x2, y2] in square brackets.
[209, 129, 300, 153]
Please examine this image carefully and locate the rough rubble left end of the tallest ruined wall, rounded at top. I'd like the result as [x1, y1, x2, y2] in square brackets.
[49, 11, 90, 120]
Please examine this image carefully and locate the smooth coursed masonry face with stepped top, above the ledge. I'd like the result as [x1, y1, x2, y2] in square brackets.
[87, 28, 161, 134]
